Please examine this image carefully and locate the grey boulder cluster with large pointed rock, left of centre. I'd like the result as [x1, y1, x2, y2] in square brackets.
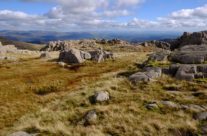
[41, 40, 113, 65]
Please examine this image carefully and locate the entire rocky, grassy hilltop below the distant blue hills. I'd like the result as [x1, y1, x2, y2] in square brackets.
[0, 31, 207, 136]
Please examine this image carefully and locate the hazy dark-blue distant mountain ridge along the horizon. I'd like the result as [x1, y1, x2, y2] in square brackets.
[0, 30, 181, 44]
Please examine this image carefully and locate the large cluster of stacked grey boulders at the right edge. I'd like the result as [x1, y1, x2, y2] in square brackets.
[133, 31, 207, 81]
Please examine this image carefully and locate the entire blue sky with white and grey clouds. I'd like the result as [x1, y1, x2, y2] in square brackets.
[0, 0, 207, 32]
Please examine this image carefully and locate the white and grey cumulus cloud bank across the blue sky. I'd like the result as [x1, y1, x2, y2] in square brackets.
[0, 0, 207, 31]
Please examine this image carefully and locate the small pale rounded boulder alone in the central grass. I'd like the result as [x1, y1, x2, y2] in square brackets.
[94, 91, 110, 102]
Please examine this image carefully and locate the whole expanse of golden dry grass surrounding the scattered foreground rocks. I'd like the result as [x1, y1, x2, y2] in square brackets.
[0, 47, 207, 136]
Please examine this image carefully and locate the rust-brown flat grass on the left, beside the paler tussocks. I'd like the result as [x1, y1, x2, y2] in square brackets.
[0, 50, 145, 133]
